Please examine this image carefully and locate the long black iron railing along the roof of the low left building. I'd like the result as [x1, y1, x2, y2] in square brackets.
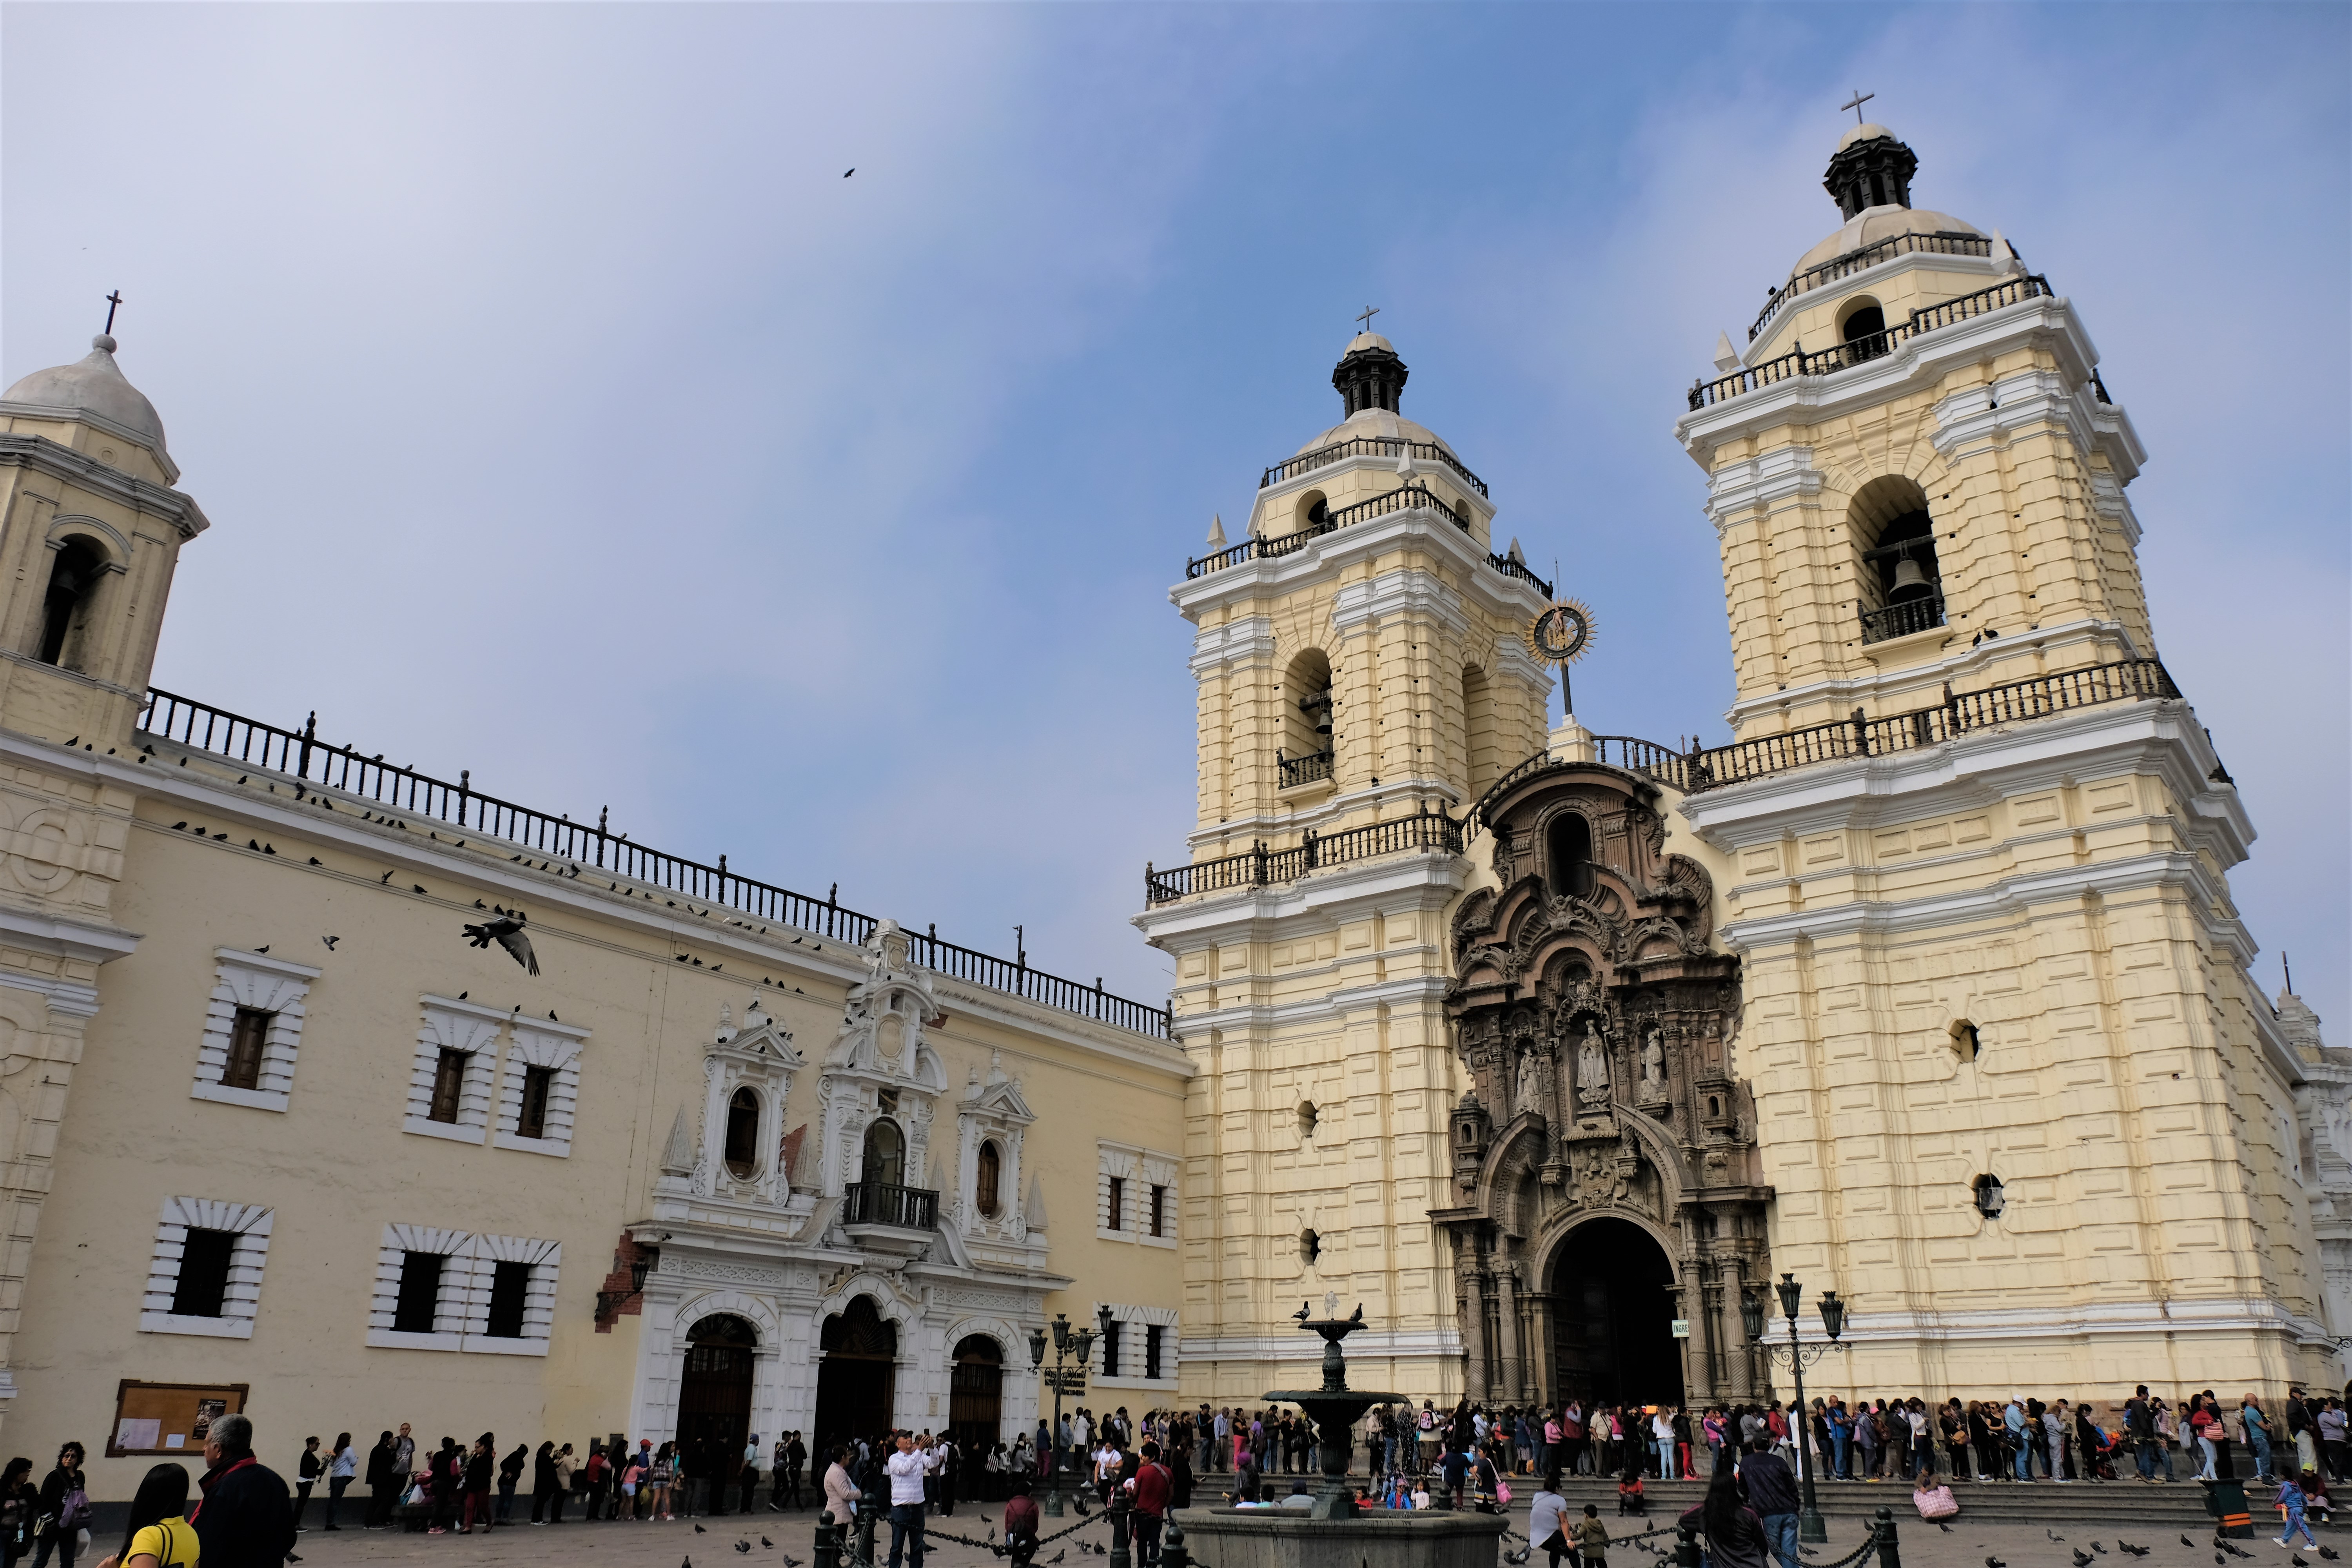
[141, 689, 1169, 1039]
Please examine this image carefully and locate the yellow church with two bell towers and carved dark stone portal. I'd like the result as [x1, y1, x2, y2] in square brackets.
[1136, 125, 2352, 1401]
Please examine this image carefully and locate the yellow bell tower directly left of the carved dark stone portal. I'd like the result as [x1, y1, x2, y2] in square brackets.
[1136, 332, 1550, 1403]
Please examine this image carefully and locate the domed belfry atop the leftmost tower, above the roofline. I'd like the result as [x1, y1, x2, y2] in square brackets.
[0, 334, 207, 750]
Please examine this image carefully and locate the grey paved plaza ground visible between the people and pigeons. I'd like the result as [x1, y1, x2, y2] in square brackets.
[267, 1488, 2352, 1568]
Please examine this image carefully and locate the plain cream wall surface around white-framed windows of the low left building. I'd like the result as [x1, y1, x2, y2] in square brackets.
[0, 764, 1183, 1495]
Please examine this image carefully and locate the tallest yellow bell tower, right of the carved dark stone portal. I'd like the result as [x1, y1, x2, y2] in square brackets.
[1677, 125, 2324, 1394]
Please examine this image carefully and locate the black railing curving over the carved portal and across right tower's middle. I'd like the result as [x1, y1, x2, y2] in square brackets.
[1463, 658, 2180, 828]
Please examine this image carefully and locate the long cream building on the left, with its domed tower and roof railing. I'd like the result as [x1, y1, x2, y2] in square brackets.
[0, 339, 1192, 1495]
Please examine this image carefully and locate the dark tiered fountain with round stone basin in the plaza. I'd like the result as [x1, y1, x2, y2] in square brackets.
[1176, 1295, 1503, 1568]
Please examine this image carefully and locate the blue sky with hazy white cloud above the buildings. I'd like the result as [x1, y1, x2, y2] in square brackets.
[0, 5, 2352, 1044]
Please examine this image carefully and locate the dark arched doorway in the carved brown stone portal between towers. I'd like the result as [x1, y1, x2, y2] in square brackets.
[1548, 1220, 1682, 1406]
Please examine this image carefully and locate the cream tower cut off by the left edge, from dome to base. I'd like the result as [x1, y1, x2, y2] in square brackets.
[0, 336, 207, 1410]
